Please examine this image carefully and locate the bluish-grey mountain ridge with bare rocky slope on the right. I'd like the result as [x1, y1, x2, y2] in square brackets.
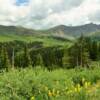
[47, 23, 100, 37]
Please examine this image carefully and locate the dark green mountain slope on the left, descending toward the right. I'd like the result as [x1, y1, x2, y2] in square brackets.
[0, 25, 74, 40]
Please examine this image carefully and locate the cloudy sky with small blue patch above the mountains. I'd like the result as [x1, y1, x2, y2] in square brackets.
[0, 0, 100, 29]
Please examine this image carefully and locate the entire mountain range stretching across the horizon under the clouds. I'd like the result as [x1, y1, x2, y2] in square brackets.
[0, 23, 100, 38]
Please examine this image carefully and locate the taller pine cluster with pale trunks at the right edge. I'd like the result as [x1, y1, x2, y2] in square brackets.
[68, 36, 100, 67]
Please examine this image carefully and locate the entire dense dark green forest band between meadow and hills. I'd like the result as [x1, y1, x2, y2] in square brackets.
[0, 36, 100, 70]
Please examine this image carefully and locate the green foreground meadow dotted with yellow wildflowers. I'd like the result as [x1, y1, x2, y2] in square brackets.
[0, 67, 100, 100]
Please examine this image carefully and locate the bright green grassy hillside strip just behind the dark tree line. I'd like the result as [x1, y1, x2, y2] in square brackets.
[0, 34, 71, 46]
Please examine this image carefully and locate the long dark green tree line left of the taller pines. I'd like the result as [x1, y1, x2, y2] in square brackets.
[0, 41, 64, 70]
